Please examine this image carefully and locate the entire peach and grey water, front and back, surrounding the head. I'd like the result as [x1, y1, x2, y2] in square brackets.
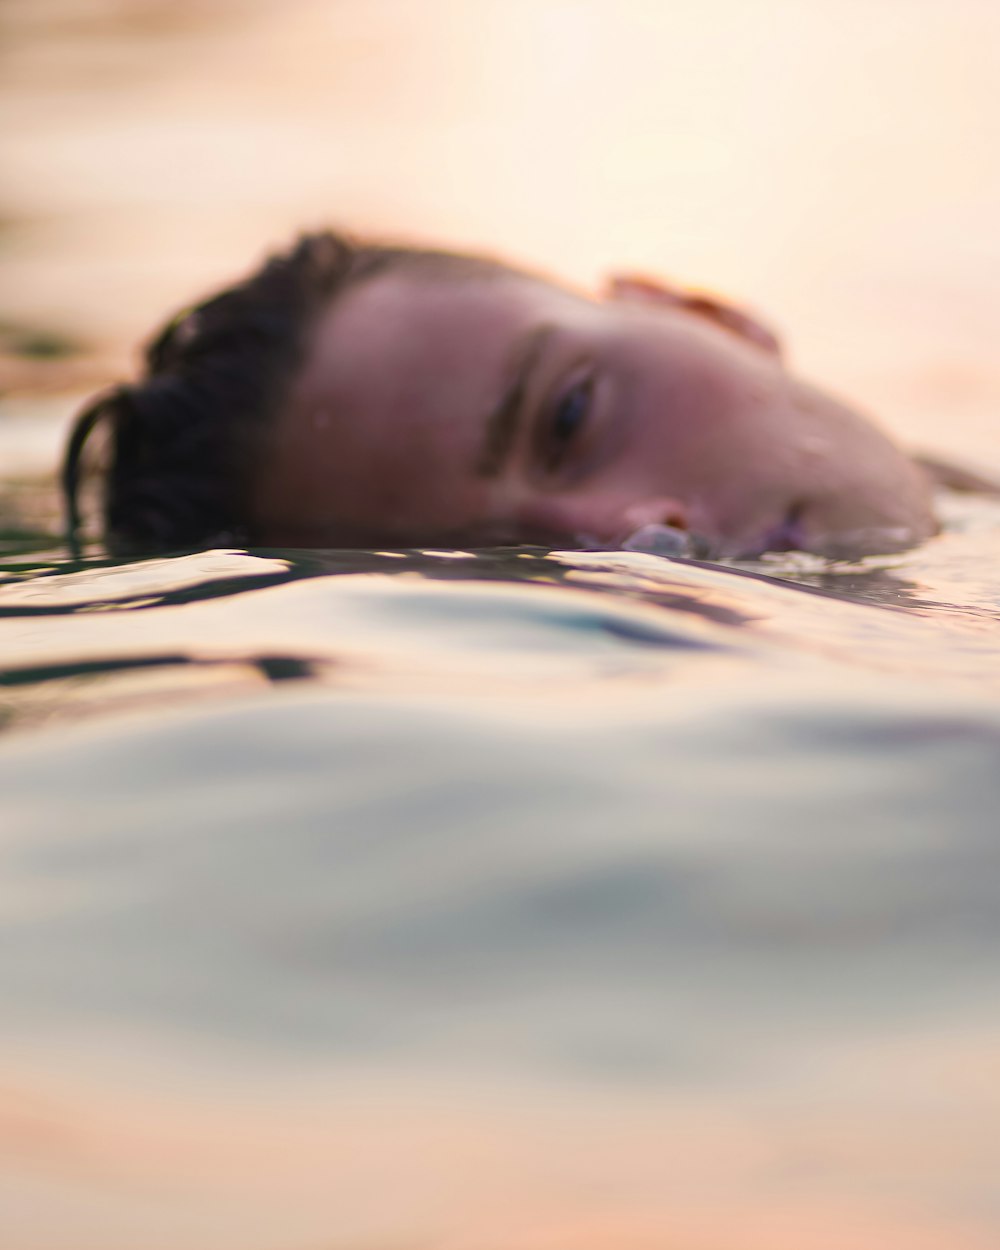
[0, 0, 1000, 1250]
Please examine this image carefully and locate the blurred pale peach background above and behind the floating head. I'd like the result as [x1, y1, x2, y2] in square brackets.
[0, 0, 1000, 482]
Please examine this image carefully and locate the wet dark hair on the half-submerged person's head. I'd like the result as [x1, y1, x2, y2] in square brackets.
[63, 231, 501, 554]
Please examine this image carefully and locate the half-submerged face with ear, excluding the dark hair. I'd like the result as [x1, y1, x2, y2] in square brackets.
[253, 266, 935, 556]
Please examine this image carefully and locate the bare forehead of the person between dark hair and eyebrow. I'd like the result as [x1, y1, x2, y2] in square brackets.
[265, 268, 584, 534]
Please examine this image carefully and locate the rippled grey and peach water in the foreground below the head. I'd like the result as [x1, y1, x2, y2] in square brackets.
[0, 496, 1000, 1250]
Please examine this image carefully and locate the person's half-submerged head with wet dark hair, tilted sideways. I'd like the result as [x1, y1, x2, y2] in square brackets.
[68, 234, 934, 555]
